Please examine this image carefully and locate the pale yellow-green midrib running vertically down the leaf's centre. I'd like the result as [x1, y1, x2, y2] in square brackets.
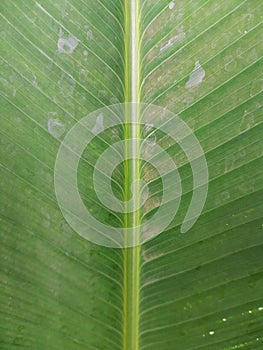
[123, 0, 141, 350]
